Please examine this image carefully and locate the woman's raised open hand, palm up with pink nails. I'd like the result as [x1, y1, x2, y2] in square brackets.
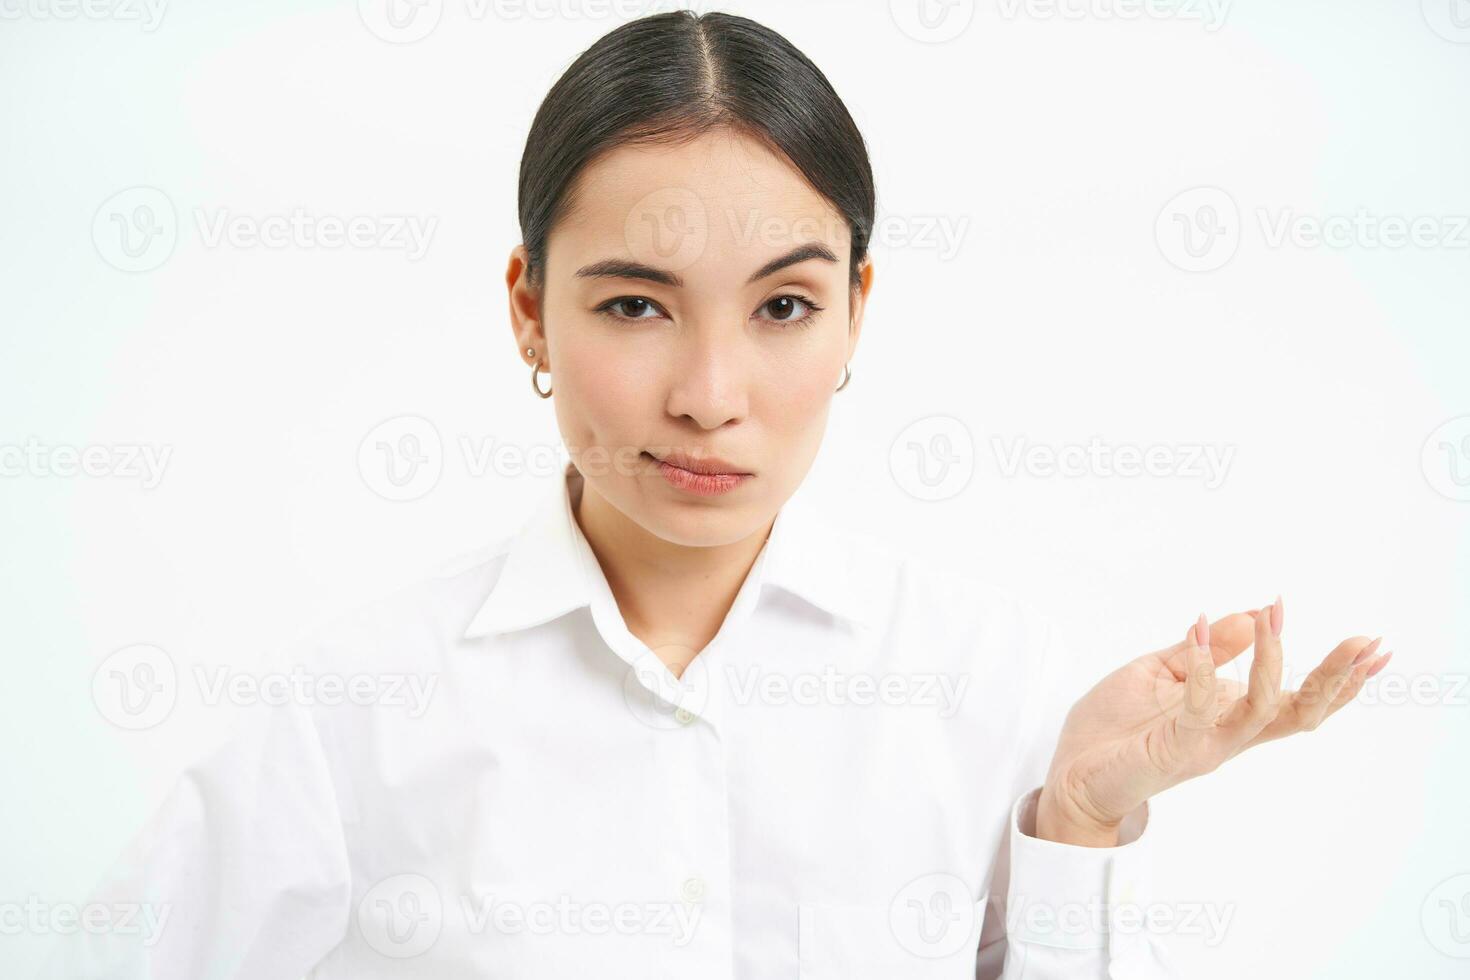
[1036, 597, 1392, 848]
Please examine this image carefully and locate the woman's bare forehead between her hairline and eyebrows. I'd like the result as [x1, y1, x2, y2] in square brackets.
[548, 129, 851, 284]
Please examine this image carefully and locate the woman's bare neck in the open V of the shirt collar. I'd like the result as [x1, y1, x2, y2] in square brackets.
[567, 473, 773, 676]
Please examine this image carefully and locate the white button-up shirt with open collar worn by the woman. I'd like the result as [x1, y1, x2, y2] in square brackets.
[46, 466, 1167, 980]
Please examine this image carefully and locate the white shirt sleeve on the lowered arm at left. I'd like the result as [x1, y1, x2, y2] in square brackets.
[38, 704, 351, 980]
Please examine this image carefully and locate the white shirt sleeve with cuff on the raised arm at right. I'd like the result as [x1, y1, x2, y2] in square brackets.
[976, 610, 1175, 980]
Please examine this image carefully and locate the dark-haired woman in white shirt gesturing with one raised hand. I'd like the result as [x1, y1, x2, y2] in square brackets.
[57, 12, 1388, 980]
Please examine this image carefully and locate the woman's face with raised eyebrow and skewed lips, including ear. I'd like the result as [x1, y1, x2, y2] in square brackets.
[507, 129, 872, 545]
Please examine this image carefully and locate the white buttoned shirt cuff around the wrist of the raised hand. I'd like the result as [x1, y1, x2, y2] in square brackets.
[1005, 786, 1151, 956]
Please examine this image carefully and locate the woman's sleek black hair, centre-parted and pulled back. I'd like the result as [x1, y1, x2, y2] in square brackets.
[517, 10, 875, 302]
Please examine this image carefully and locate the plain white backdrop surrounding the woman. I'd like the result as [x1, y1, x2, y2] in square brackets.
[0, 0, 1470, 980]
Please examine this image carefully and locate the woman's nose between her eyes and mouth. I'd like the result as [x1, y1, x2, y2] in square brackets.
[667, 323, 751, 430]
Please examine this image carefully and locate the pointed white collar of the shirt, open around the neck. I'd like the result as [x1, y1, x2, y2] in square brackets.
[465, 463, 879, 639]
